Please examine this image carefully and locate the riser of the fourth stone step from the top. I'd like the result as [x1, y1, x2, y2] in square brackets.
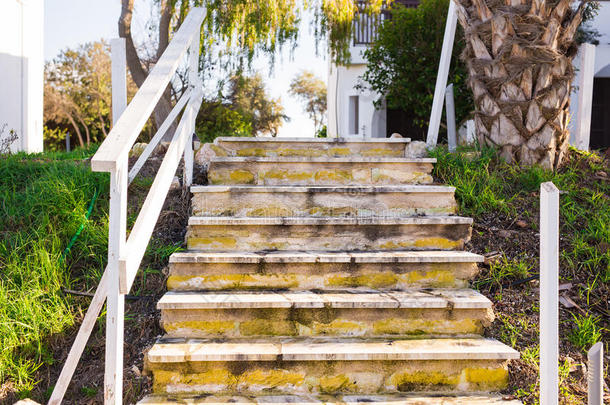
[186, 222, 471, 252]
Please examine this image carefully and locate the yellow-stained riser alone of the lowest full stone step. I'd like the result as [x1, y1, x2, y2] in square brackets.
[148, 360, 508, 395]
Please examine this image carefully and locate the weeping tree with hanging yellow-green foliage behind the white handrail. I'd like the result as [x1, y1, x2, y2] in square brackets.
[119, 0, 392, 131]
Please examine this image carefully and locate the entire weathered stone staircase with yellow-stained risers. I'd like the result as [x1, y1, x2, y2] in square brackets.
[140, 138, 519, 405]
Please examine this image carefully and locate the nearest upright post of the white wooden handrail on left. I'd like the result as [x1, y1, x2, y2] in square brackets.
[104, 158, 128, 405]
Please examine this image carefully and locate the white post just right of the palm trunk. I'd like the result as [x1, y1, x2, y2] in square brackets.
[575, 44, 595, 150]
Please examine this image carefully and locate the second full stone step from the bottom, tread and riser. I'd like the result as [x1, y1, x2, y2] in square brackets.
[157, 289, 493, 338]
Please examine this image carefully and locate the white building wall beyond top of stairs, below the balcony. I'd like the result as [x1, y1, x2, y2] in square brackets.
[327, 46, 386, 138]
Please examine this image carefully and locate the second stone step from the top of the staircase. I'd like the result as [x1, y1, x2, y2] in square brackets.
[208, 157, 436, 186]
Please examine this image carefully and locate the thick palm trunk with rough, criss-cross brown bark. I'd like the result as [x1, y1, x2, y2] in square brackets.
[455, 0, 584, 169]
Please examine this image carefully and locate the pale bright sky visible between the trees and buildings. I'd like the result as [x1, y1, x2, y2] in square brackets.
[44, 0, 328, 137]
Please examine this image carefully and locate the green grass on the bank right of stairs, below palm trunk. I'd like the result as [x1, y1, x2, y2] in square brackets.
[431, 148, 610, 283]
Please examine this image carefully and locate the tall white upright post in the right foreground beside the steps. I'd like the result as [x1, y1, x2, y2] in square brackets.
[540, 182, 559, 405]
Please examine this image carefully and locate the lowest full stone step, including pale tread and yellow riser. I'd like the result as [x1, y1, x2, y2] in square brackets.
[146, 338, 519, 395]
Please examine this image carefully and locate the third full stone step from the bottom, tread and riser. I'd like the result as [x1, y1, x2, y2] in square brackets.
[167, 251, 483, 291]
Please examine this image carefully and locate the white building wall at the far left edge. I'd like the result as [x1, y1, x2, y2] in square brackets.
[0, 0, 44, 153]
